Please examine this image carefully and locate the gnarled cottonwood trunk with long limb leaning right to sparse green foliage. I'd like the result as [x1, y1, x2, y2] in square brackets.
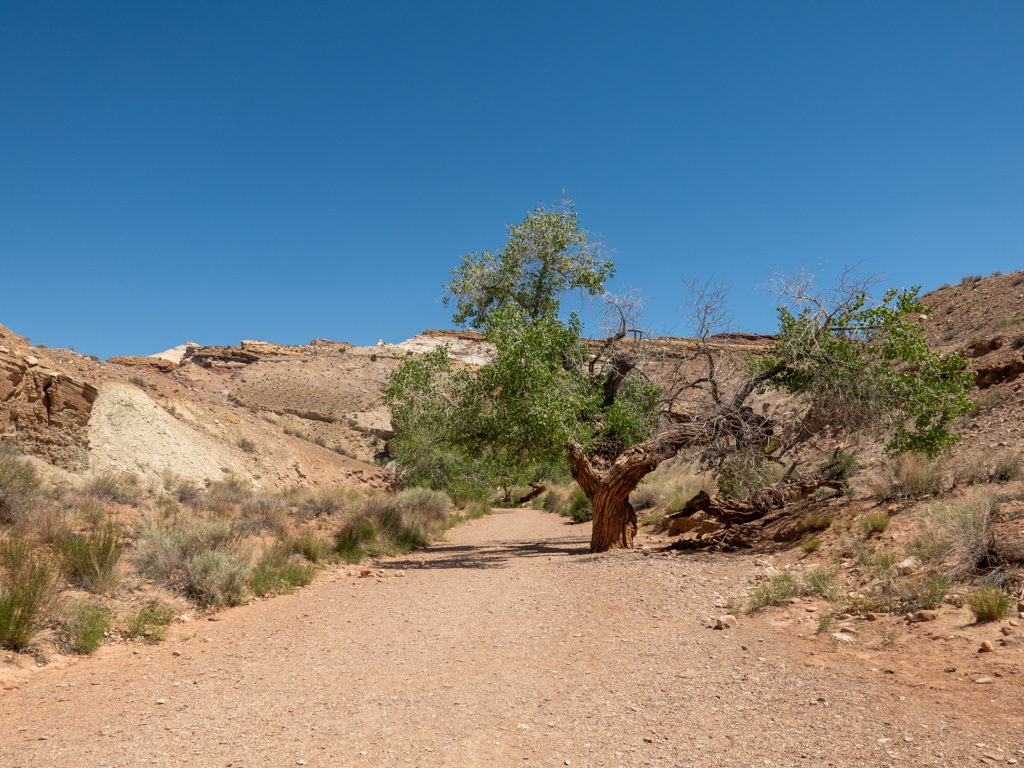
[568, 270, 973, 552]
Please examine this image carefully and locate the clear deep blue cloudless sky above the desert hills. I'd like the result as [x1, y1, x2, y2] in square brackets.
[0, 0, 1024, 357]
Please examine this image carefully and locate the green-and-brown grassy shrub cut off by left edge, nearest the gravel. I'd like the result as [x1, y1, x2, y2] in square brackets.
[0, 537, 56, 650]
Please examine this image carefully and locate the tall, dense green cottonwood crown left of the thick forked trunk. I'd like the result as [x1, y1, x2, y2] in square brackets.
[382, 199, 658, 500]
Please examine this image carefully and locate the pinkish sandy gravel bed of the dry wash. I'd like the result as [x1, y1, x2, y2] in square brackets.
[0, 510, 1024, 768]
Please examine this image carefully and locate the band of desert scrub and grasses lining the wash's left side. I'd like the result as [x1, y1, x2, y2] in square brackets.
[0, 462, 489, 653]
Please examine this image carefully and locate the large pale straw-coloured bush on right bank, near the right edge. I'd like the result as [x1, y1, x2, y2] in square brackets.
[907, 494, 998, 581]
